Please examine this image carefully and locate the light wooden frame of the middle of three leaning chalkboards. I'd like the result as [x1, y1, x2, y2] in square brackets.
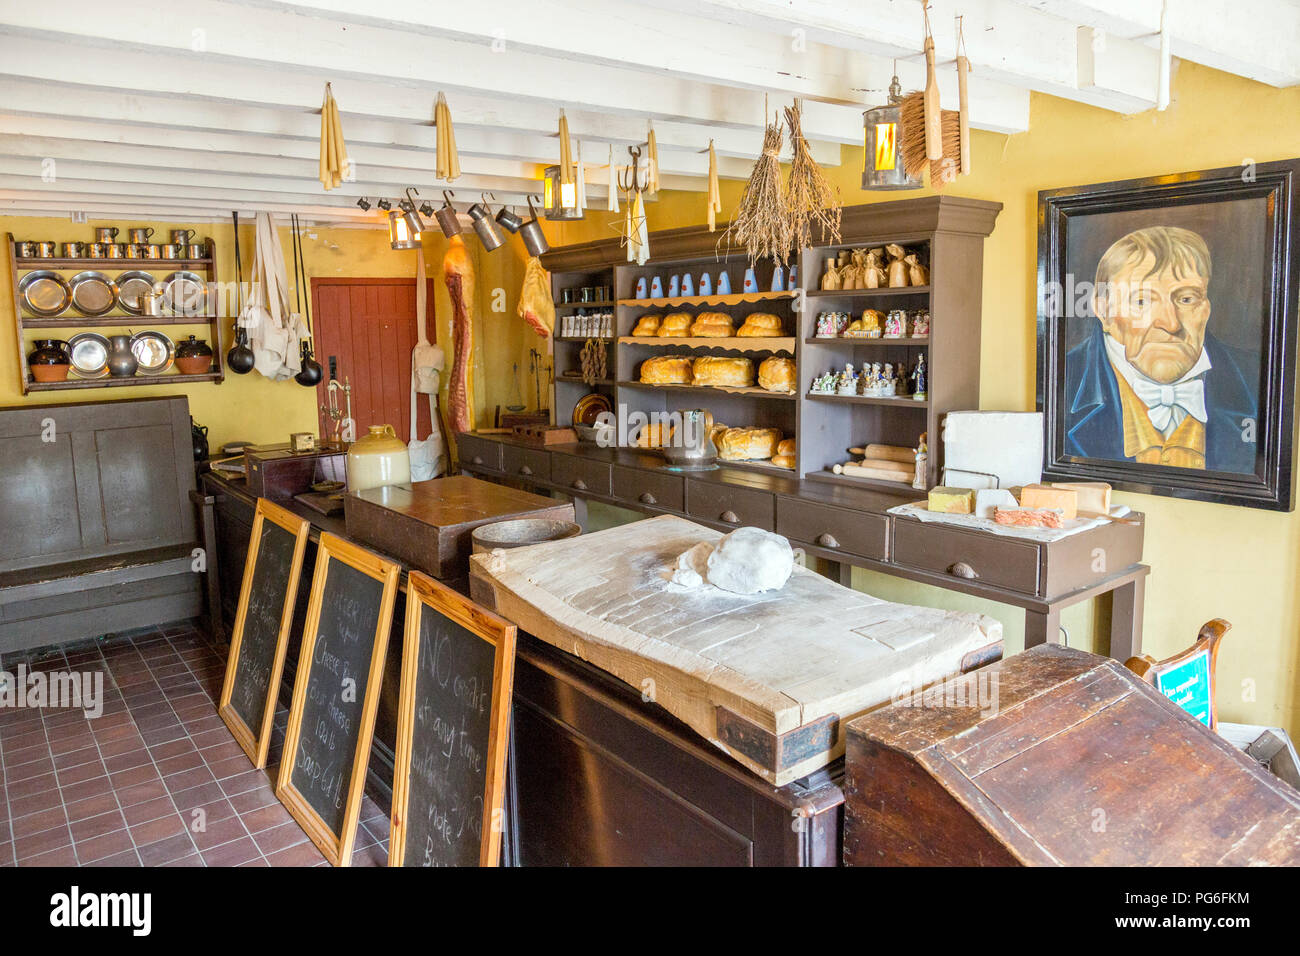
[276, 533, 402, 866]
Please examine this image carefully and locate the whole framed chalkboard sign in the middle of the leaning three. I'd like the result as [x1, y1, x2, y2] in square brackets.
[276, 535, 399, 866]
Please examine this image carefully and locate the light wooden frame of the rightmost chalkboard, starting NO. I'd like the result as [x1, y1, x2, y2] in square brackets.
[389, 571, 517, 866]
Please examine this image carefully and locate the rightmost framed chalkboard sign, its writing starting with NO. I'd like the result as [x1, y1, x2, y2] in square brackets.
[389, 571, 515, 866]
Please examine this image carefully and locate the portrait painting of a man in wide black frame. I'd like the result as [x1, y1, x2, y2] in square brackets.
[1037, 160, 1300, 511]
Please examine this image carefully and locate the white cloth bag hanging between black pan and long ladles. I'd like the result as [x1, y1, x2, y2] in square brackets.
[239, 212, 307, 381]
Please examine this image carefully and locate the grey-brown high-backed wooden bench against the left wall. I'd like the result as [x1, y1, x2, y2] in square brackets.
[0, 395, 202, 652]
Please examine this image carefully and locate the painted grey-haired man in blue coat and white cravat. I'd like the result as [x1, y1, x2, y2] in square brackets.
[1065, 226, 1258, 473]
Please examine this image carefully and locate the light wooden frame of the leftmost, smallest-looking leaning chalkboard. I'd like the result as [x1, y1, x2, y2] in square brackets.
[219, 498, 312, 770]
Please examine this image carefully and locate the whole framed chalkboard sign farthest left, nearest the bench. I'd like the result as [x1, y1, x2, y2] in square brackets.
[217, 498, 311, 770]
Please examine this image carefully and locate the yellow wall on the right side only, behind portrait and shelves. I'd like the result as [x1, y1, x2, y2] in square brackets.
[553, 62, 1300, 731]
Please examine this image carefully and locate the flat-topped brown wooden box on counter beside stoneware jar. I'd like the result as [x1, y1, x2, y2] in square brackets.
[343, 475, 573, 580]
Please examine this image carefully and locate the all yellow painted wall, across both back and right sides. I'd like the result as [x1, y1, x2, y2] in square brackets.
[0, 62, 1300, 727]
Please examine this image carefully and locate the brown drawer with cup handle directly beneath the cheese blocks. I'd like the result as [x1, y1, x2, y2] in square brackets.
[892, 518, 1039, 594]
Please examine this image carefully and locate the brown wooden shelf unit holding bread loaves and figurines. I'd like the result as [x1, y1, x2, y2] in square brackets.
[542, 196, 1001, 494]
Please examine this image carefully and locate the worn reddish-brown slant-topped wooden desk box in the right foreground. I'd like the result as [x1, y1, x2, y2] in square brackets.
[844, 645, 1300, 866]
